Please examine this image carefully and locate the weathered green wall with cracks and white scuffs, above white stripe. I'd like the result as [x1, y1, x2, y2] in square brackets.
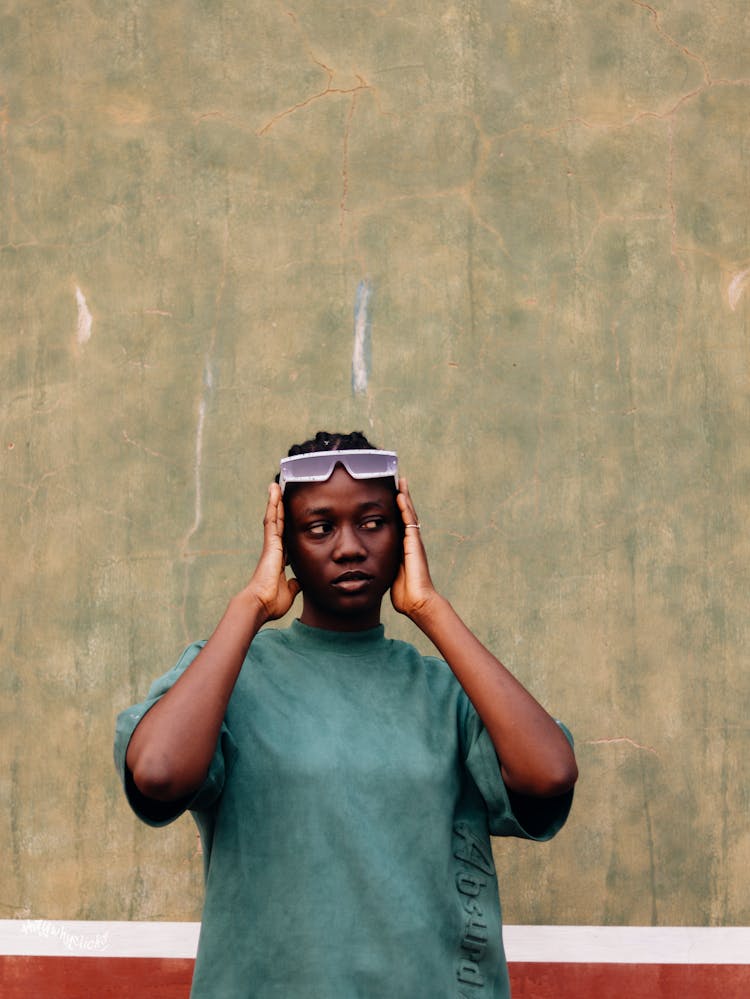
[0, 0, 750, 924]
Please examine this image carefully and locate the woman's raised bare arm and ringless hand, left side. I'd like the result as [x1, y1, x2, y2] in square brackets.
[126, 483, 299, 801]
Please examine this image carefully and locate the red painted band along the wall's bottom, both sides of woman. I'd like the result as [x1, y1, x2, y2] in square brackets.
[0, 955, 750, 999]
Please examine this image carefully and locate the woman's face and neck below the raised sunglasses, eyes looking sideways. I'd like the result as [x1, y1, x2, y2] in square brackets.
[284, 465, 402, 631]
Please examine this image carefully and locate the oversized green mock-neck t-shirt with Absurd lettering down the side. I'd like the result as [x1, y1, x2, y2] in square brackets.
[115, 621, 572, 999]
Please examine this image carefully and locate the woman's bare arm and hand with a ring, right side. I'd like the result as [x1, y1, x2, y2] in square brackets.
[391, 479, 578, 797]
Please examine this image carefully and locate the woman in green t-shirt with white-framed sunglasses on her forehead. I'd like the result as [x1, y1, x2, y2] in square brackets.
[115, 432, 577, 999]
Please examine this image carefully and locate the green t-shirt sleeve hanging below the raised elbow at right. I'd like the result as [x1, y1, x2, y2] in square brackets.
[464, 703, 573, 841]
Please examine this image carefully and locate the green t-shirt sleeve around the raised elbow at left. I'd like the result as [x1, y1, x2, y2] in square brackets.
[114, 642, 237, 826]
